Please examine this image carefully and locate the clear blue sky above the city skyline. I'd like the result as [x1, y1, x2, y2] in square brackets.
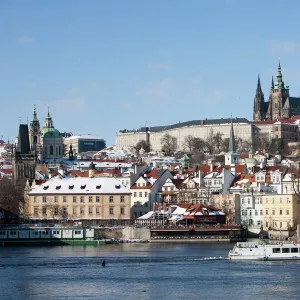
[0, 0, 300, 145]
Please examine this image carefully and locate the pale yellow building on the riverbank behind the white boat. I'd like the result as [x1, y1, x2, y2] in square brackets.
[262, 194, 299, 230]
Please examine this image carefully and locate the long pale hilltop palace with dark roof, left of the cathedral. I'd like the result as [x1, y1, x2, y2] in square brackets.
[116, 118, 253, 152]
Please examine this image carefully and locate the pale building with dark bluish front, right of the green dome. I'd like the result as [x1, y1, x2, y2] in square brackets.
[64, 134, 106, 155]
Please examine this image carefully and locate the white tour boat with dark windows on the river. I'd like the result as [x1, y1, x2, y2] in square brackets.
[228, 242, 300, 260]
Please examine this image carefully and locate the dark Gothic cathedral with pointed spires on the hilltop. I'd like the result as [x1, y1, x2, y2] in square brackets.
[253, 62, 300, 121]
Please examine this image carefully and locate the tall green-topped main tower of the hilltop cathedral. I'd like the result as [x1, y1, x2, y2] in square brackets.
[266, 61, 290, 120]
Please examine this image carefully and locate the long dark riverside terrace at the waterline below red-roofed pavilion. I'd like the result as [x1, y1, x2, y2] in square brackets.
[150, 224, 247, 242]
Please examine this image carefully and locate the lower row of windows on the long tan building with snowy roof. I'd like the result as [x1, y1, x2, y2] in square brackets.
[33, 207, 125, 216]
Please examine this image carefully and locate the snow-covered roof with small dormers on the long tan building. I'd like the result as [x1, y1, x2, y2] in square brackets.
[29, 177, 131, 195]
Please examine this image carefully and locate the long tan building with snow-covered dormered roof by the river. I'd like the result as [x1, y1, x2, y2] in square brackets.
[25, 177, 131, 220]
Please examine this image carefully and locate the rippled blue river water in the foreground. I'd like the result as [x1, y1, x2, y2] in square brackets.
[0, 243, 300, 300]
